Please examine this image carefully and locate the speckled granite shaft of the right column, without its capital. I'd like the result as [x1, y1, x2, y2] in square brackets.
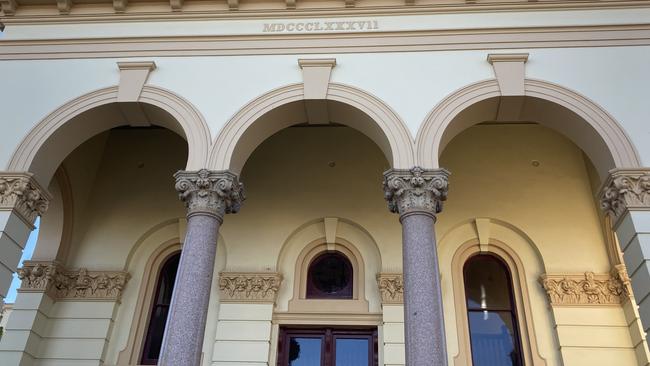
[401, 213, 447, 366]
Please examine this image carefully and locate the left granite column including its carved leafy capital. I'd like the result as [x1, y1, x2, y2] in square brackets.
[158, 169, 244, 366]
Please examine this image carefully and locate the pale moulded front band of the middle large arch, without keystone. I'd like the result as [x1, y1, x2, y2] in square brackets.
[208, 83, 415, 172]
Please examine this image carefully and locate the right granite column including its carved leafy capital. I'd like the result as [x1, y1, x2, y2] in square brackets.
[384, 167, 449, 366]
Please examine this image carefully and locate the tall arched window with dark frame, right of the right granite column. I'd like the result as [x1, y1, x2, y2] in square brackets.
[463, 254, 523, 366]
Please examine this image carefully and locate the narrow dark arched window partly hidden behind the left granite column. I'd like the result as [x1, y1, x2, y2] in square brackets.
[140, 252, 181, 365]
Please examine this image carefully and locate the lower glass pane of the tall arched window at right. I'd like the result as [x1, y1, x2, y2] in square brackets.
[469, 311, 520, 366]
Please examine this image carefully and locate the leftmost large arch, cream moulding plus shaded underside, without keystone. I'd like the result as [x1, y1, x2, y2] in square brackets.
[7, 85, 210, 184]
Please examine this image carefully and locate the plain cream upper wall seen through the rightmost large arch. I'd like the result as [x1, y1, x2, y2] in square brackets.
[436, 124, 611, 273]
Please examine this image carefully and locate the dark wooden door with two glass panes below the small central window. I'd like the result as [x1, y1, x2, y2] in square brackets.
[278, 327, 378, 366]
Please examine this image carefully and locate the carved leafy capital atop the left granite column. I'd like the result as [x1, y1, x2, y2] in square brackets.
[174, 169, 246, 220]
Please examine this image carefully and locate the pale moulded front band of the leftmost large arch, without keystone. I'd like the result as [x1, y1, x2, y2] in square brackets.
[7, 85, 210, 184]
